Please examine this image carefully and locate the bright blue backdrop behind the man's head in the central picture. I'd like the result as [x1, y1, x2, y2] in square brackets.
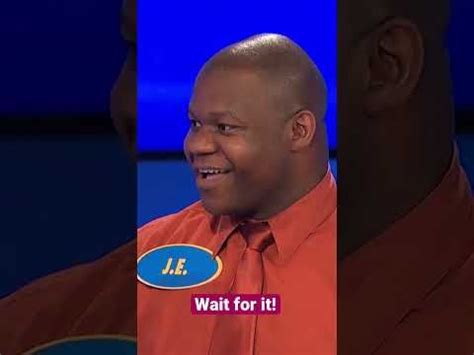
[138, 0, 336, 152]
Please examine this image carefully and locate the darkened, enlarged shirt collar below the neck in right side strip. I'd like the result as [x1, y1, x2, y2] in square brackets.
[338, 145, 474, 354]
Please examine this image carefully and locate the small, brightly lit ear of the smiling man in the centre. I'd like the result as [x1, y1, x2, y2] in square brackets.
[289, 110, 319, 152]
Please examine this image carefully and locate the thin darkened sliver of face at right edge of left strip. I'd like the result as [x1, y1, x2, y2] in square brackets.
[110, 0, 137, 156]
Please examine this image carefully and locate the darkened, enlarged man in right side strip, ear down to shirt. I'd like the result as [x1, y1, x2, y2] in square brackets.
[338, 0, 474, 355]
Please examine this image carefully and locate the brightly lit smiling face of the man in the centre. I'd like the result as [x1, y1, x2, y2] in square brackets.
[184, 69, 289, 218]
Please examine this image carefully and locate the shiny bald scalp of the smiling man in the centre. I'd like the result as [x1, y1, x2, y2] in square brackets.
[199, 34, 327, 120]
